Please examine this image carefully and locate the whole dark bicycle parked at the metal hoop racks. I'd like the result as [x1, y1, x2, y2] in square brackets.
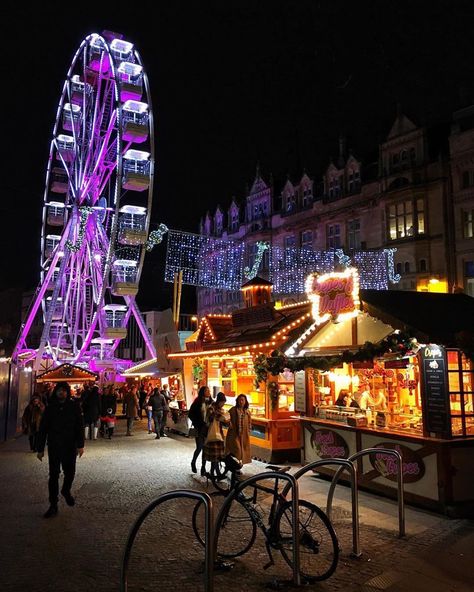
[192, 464, 339, 583]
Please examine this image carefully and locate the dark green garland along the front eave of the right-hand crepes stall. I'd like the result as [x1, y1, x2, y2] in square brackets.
[253, 332, 418, 387]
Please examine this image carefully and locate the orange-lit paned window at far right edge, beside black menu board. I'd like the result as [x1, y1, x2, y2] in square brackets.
[446, 349, 474, 437]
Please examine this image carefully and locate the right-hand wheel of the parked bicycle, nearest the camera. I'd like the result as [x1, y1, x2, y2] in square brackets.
[275, 500, 339, 582]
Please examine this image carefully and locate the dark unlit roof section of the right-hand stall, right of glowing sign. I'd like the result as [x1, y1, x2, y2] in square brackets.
[360, 290, 474, 345]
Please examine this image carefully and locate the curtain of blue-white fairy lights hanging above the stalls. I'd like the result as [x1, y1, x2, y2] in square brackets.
[162, 225, 400, 294]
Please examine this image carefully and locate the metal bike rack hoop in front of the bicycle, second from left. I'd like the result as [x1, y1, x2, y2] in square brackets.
[214, 472, 302, 586]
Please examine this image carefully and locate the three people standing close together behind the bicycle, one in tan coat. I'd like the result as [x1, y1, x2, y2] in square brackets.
[188, 386, 252, 476]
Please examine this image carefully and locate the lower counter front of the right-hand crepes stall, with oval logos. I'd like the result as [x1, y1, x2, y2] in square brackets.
[301, 417, 474, 517]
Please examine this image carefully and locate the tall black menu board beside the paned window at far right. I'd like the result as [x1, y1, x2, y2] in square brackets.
[419, 344, 451, 438]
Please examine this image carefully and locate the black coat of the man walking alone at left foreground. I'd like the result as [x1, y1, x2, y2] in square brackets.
[37, 397, 84, 452]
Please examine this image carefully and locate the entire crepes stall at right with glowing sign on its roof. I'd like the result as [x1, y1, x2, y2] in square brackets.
[258, 272, 474, 515]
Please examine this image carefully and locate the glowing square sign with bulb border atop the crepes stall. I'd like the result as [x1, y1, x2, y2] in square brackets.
[306, 267, 360, 325]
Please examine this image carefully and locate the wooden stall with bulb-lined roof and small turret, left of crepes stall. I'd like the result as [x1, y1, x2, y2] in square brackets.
[168, 278, 311, 462]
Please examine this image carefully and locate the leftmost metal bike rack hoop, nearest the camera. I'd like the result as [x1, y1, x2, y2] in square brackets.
[120, 489, 215, 592]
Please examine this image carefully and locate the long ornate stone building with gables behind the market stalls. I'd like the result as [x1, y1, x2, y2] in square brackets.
[197, 107, 474, 316]
